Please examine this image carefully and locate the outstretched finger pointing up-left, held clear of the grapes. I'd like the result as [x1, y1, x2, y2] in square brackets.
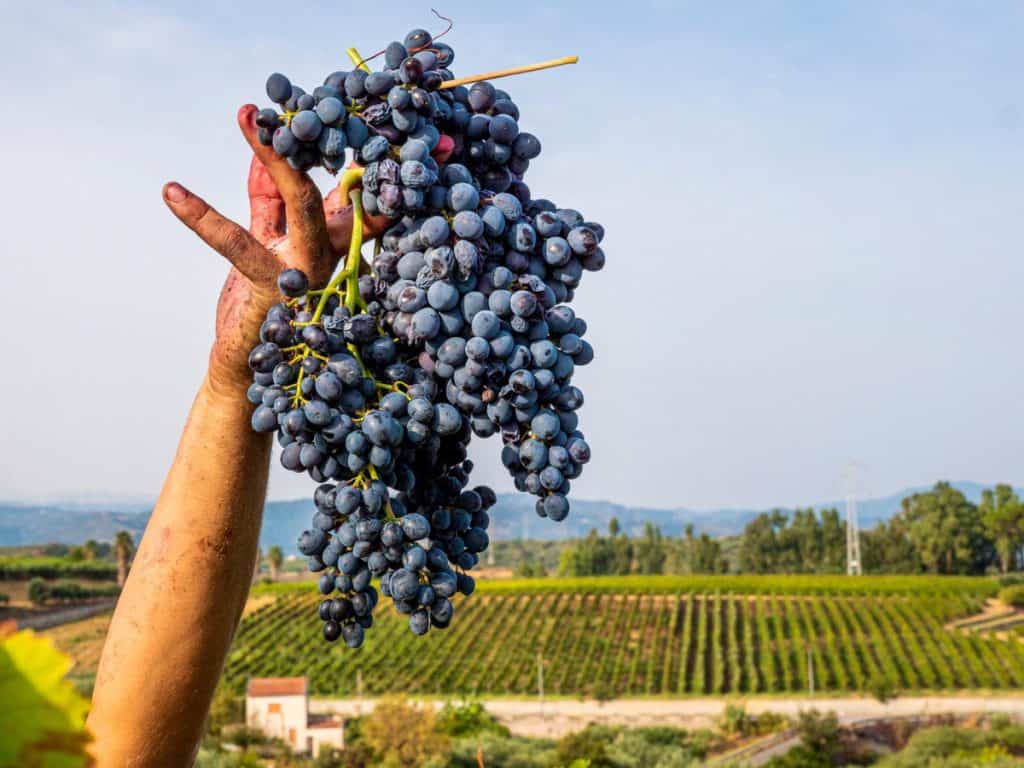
[164, 181, 278, 285]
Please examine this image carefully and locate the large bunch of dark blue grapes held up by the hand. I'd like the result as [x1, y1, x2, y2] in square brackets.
[249, 24, 604, 647]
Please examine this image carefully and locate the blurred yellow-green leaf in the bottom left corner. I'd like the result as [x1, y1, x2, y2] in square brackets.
[0, 630, 89, 768]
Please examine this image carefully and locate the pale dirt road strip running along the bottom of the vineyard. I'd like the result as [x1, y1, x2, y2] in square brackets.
[309, 693, 1024, 738]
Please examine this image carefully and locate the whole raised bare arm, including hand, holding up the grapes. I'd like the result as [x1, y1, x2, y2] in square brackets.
[89, 105, 380, 768]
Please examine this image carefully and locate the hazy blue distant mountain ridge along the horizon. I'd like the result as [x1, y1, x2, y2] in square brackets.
[0, 482, 1007, 553]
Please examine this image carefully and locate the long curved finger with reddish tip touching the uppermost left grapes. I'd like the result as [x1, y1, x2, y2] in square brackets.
[239, 104, 327, 265]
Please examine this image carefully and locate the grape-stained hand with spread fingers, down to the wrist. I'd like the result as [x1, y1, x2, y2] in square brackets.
[163, 104, 388, 397]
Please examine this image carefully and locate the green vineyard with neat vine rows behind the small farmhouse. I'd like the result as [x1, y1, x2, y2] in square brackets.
[216, 577, 1024, 696]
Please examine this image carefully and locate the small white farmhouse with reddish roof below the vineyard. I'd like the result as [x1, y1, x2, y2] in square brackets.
[246, 677, 345, 757]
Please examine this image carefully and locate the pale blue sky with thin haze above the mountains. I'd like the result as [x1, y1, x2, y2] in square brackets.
[0, 0, 1024, 507]
